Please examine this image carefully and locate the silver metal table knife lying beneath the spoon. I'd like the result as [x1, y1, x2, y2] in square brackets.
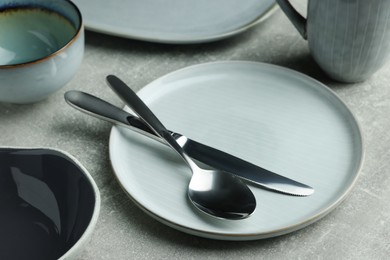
[65, 90, 314, 196]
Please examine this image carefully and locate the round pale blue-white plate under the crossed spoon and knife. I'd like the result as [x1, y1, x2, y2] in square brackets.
[109, 61, 363, 240]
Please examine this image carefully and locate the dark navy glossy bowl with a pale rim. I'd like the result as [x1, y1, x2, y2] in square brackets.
[0, 148, 100, 260]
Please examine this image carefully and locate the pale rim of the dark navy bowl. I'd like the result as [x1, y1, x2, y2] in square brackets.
[0, 146, 101, 260]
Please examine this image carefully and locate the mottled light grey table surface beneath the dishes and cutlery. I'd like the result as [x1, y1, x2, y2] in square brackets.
[0, 1, 390, 259]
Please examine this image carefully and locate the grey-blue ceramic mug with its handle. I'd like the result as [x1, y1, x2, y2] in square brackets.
[276, 0, 390, 83]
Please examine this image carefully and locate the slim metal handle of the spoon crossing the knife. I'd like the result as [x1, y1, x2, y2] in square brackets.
[107, 75, 198, 169]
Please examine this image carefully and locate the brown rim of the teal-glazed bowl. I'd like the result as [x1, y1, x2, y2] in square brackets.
[0, 0, 84, 69]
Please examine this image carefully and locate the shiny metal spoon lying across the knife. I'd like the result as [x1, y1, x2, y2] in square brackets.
[107, 75, 256, 220]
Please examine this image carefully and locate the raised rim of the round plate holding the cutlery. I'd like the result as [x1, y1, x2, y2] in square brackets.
[109, 60, 365, 241]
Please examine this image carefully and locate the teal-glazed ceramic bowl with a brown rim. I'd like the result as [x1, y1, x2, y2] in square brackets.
[0, 0, 84, 103]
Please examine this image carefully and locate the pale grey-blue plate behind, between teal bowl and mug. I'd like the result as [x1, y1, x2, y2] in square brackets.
[74, 0, 276, 43]
